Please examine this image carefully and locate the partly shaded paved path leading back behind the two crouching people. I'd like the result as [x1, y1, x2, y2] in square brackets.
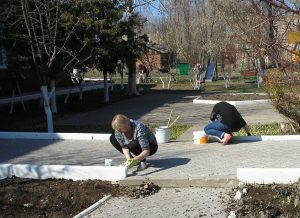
[56, 93, 284, 128]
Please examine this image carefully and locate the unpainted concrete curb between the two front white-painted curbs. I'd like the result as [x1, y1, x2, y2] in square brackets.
[118, 175, 238, 188]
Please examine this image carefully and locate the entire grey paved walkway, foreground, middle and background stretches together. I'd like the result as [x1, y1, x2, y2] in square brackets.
[0, 91, 300, 218]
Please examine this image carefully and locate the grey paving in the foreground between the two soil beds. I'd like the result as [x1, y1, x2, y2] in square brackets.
[87, 188, 228, 218]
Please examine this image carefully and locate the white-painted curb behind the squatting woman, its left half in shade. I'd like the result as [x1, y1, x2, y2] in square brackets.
[0, 132, 111, 141]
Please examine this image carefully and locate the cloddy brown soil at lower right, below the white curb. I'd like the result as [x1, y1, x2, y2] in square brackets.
[228, 183, 300, 218]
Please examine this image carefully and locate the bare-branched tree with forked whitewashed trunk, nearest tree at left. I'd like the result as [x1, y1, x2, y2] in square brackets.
[1, 0, 87, 132]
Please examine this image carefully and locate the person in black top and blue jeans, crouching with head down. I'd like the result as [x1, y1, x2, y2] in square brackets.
[204, 102, 251, 145]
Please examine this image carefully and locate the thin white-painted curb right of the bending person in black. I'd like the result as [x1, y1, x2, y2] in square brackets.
[195, 131, 300, 142]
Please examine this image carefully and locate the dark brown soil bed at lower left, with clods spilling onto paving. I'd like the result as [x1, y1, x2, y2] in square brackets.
[0, 177, 159, 218]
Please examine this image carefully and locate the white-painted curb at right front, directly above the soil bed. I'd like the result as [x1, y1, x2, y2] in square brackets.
[236, 168, 300, 184]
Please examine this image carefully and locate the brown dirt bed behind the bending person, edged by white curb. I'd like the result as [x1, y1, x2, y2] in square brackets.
[199, 93, 268, 101]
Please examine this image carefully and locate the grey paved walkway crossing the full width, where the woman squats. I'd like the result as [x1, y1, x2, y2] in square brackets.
[0, 139, 300, 187]
